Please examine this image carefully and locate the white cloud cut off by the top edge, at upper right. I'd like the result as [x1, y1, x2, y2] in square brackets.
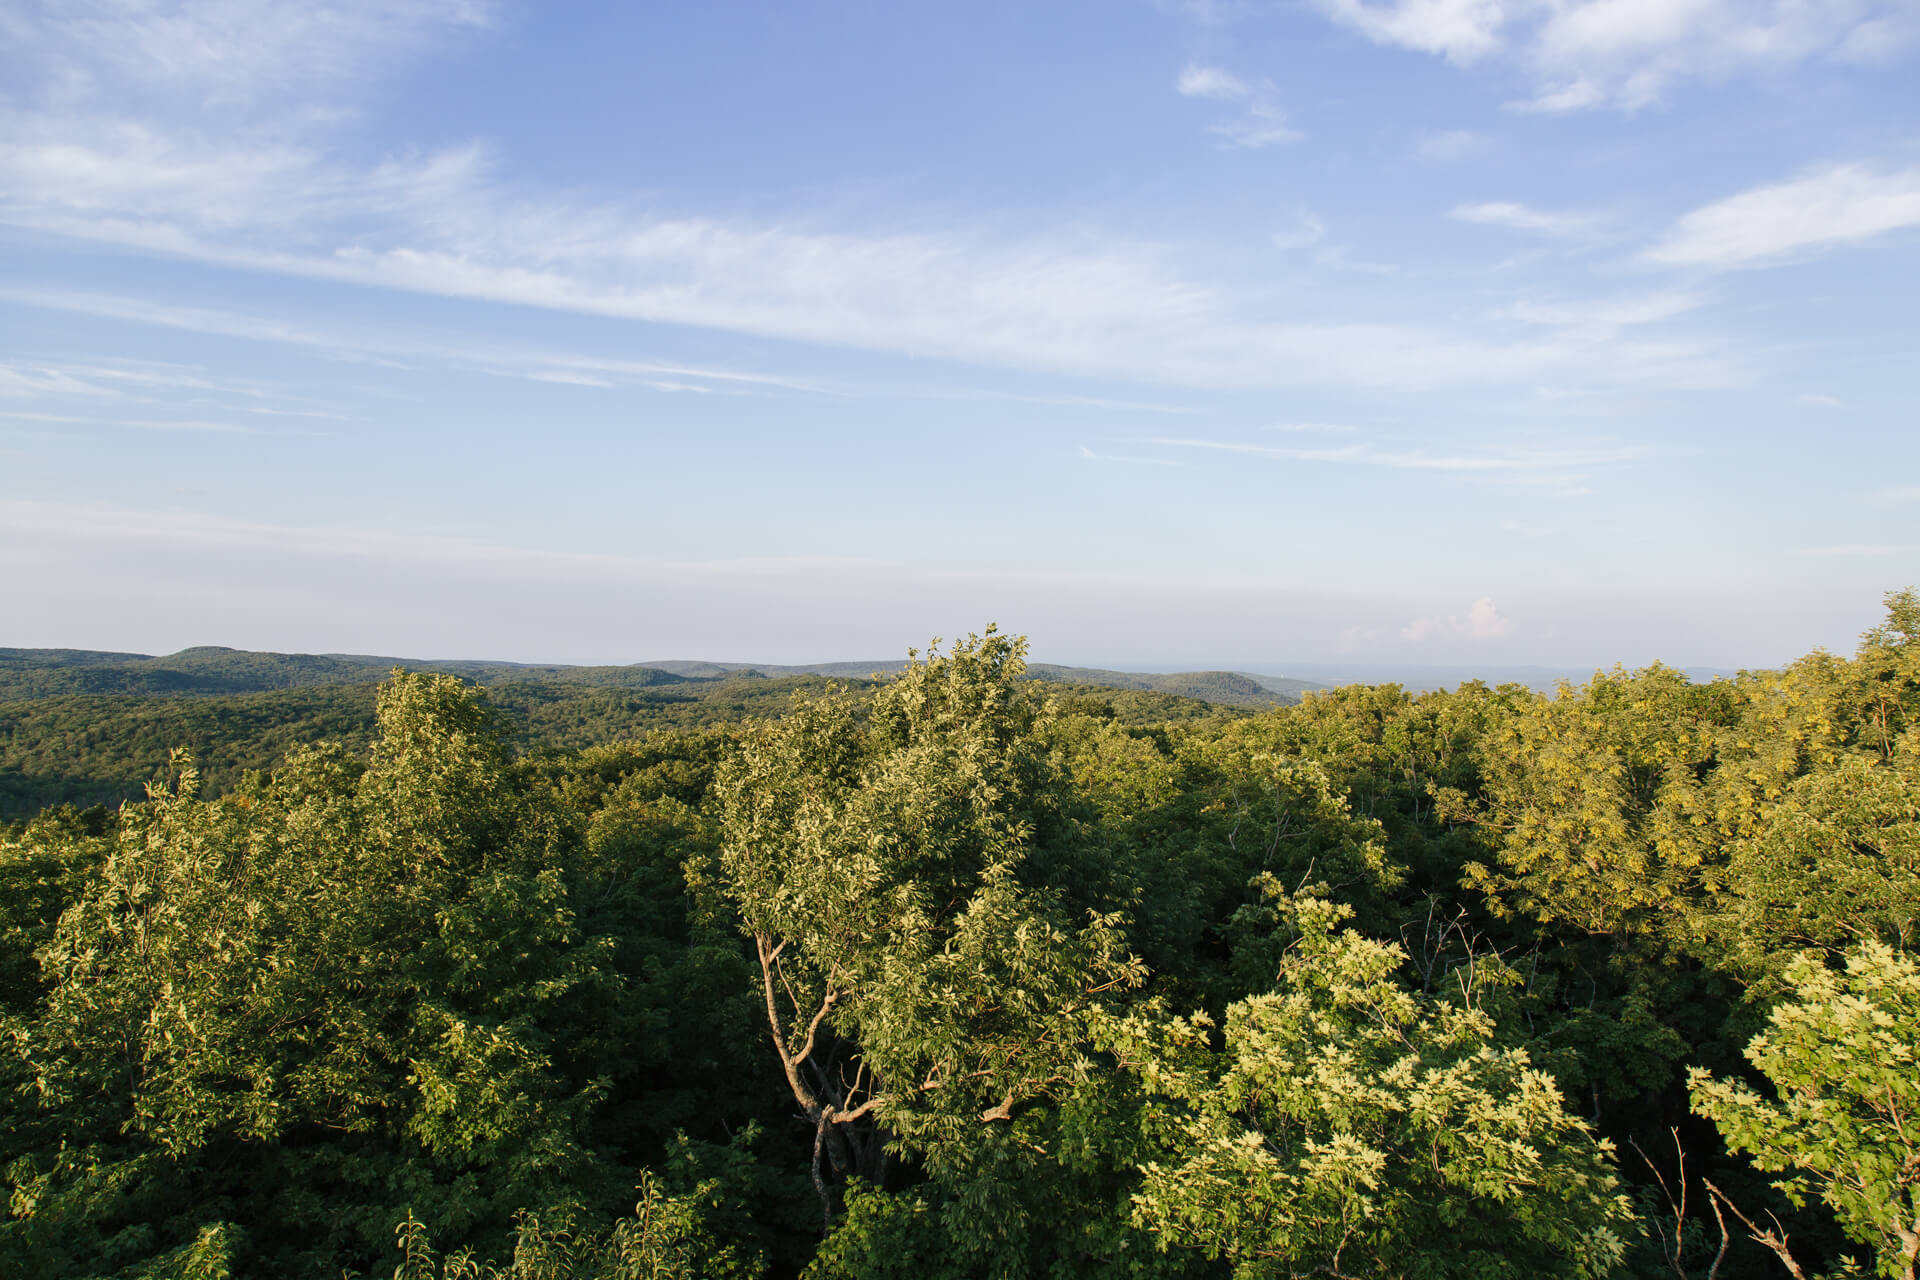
[1311, 0, 1920, 111]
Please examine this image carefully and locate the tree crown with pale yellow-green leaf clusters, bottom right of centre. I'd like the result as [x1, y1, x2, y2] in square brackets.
[1114, 898, 1630, 1278]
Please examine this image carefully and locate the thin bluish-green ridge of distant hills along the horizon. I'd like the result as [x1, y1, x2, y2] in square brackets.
[0, 645, 1323, 708]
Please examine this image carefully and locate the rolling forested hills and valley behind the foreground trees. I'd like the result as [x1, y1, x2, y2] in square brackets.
[0, 647, 1244, 821]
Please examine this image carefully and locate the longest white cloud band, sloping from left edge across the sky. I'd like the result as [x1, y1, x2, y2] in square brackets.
[0, 140, 1724, 388]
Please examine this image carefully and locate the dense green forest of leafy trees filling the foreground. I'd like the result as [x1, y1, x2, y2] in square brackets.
[0, 591, 1920, 1280]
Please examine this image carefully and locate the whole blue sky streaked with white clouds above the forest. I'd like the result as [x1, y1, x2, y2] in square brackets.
[0, 0, 1920, 668]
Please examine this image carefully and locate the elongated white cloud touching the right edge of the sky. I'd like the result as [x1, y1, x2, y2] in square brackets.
[1644, 165, 1920, 269]
